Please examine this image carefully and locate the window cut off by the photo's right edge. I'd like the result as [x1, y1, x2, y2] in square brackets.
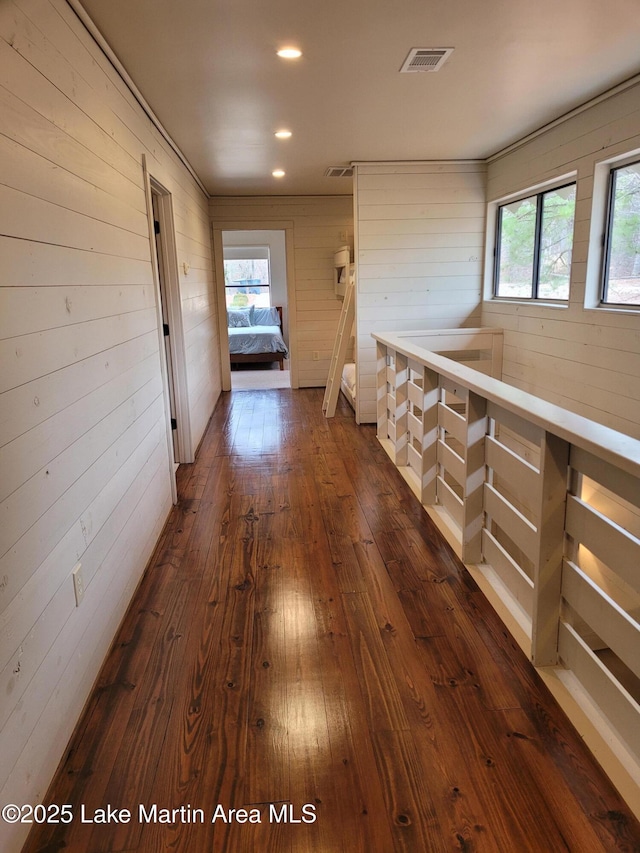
[602, 162, 640, 305]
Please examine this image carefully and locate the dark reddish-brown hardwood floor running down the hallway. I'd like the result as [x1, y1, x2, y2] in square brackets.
[25, 389, 640, 853]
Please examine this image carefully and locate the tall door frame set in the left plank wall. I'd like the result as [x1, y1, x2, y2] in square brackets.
[142, 154, 194, 503]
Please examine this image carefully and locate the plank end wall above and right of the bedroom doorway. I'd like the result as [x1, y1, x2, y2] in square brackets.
[209, 195, 353, 388]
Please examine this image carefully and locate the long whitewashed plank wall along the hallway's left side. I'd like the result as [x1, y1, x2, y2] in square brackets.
[0, 0, 220, 851]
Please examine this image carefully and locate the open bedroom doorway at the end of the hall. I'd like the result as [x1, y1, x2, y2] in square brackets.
[221, 228, 291, 391]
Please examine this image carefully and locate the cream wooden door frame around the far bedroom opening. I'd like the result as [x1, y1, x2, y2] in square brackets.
[211, 219, 299, 391]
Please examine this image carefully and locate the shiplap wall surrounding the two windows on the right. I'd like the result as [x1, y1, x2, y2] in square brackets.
[482, 85, 640, 438]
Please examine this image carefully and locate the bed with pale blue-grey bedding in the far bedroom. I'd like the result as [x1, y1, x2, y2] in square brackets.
[227, 306, 289, 370]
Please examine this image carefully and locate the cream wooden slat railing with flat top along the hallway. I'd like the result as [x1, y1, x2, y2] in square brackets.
[373, 329, 640, 762]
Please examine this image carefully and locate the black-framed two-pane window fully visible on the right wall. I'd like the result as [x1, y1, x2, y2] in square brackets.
[494, 183, 576, 301]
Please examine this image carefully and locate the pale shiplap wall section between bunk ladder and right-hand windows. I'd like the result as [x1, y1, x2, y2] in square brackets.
[355, 162, 485, 423]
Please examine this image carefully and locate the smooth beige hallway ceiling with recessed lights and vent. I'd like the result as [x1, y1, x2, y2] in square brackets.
[77, 0, 640, 195]
